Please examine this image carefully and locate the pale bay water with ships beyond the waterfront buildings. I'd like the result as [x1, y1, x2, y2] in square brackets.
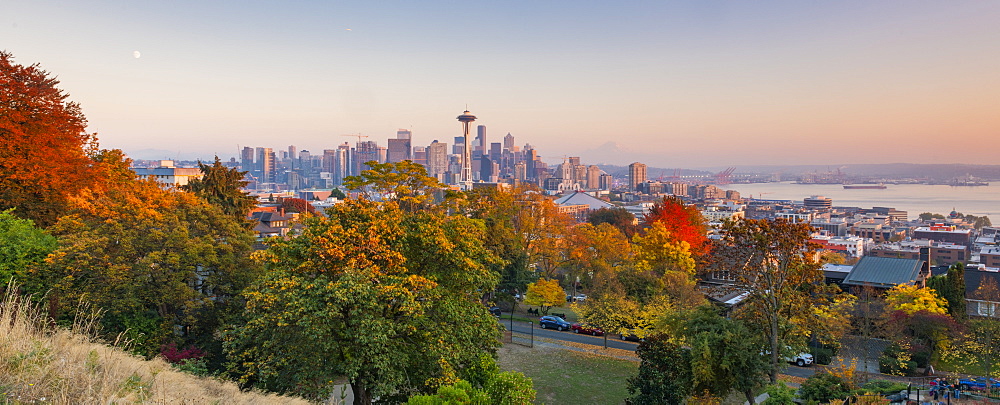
[723, 182, 1000, 220]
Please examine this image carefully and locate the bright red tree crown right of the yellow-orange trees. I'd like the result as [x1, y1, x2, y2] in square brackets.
[642, 196, 710, 257]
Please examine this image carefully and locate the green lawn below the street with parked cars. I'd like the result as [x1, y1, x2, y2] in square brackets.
[499, 344, 639, 405]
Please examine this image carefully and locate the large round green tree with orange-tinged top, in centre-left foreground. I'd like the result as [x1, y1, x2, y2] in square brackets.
[225, 200, 508, 404]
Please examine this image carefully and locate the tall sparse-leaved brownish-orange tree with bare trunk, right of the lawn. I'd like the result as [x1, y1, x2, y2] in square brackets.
[712, 219, 823, 383]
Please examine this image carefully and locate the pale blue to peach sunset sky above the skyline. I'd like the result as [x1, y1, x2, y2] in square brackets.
[0, 0, 1000, 167]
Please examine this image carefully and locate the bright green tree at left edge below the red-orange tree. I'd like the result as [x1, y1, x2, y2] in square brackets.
[0, 209, 56, 284]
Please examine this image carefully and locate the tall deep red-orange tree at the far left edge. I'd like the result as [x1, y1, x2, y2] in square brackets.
[0, 51, 98, 227]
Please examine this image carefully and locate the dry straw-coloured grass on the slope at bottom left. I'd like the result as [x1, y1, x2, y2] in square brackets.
[0, 288, 308, 404]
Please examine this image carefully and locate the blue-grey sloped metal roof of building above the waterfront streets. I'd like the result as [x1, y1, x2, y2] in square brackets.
[841, 256, 930, 291]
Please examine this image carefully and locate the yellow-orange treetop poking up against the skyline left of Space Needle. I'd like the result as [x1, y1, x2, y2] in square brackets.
[344, 160, 445, 211]
